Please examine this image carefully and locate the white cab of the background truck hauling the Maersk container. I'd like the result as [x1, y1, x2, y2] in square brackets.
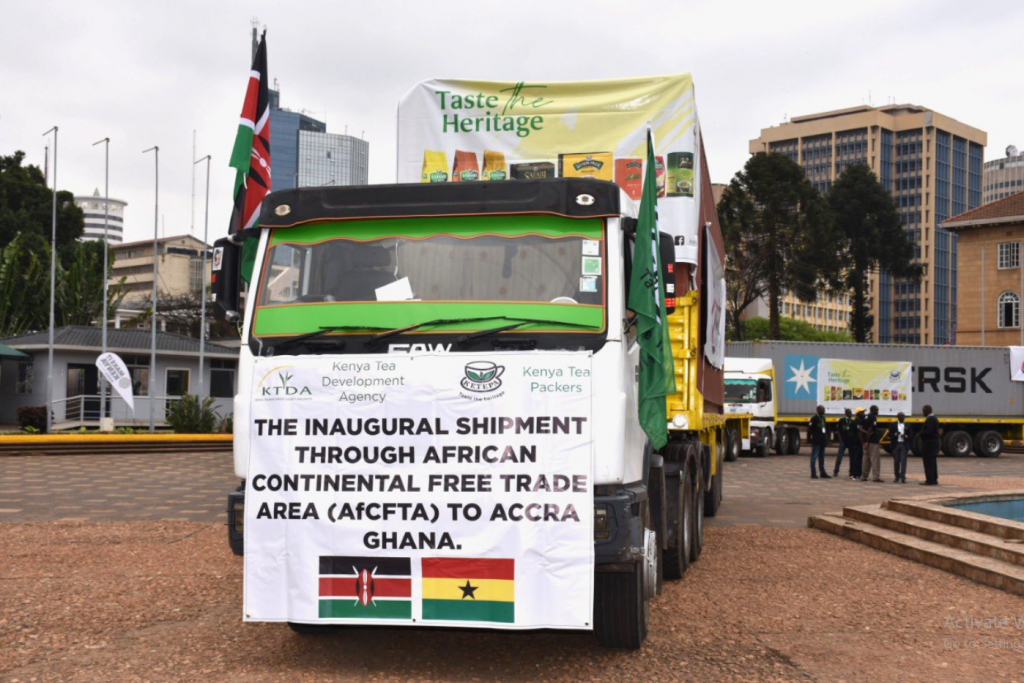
[725, 356, 801, 458]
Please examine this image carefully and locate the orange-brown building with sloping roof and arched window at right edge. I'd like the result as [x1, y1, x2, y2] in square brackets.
[942, 191, 1024, 346]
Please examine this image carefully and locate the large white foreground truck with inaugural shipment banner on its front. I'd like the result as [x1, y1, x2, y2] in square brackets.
[214, 77, 750, 649]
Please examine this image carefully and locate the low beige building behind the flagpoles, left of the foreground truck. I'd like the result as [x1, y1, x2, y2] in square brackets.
[110, 234, 211, 304]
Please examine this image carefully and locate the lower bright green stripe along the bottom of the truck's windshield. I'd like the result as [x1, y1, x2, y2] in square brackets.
[254, 301, 604, 338]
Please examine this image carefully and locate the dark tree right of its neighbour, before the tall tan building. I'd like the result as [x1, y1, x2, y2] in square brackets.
[828, 164, 922, 343]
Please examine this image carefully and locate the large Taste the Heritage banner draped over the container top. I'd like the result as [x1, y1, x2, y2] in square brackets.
[398, 74, 700, 263]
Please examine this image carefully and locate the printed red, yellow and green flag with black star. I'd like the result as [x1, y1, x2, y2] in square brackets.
[423, 557, 515, 624]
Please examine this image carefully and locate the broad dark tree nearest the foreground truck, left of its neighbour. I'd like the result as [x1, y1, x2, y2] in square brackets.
[718, 153, 840, 339]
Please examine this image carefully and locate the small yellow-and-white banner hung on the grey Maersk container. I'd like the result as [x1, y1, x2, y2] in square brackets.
[817, 358, 913, 415]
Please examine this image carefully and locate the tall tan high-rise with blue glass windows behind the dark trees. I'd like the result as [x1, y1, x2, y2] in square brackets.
[750, 104, 988, 344]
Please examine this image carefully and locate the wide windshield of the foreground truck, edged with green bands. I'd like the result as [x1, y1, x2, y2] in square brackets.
[254, 216, 606, 335]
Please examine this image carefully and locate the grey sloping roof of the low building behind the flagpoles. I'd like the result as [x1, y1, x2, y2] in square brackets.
[3, 325, 238, 356]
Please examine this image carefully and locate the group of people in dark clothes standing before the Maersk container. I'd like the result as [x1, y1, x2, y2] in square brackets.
[807, 405, 940, 486]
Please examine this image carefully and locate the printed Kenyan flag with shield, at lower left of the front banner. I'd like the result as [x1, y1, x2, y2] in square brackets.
[319, 555, 413, 618]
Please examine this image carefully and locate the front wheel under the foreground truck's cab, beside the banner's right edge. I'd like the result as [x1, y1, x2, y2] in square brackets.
[594, 503, 657, 650]
